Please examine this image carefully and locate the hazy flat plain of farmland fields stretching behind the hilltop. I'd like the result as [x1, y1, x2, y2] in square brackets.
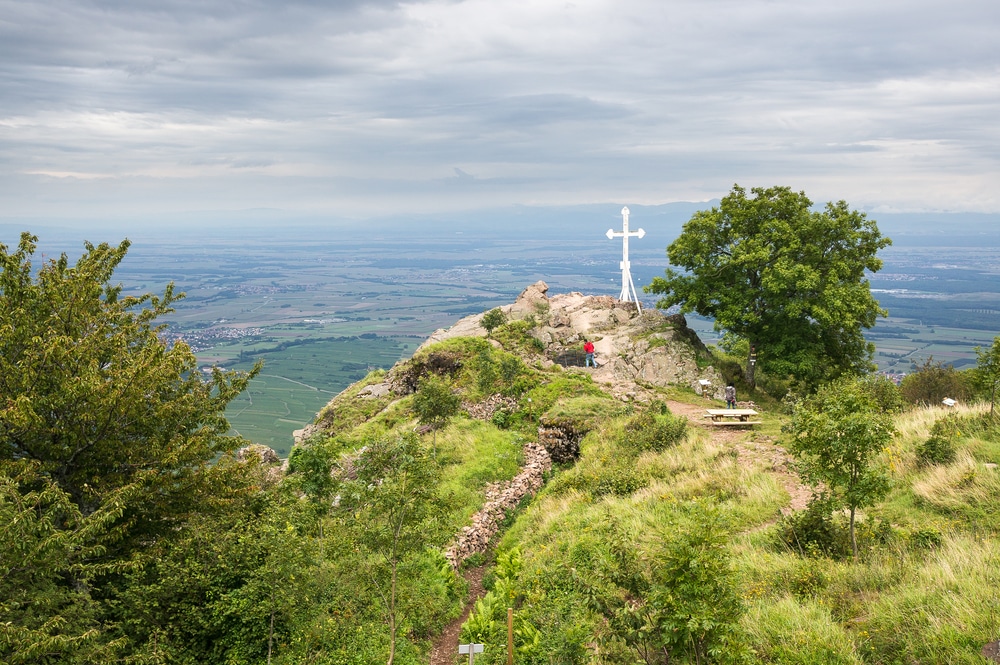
[7, 204, 1000, 455]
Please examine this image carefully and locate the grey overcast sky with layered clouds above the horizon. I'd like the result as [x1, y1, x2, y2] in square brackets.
[0, 0, 1000, 226]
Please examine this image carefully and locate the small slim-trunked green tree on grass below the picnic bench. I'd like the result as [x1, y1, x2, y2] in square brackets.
[789, 379, 895, 558]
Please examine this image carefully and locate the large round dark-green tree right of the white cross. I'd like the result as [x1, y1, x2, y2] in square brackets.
[645, 185, 891, 387]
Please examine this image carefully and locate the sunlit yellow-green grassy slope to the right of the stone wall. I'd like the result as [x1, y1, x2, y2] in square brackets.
[466, 396, 1000, 663]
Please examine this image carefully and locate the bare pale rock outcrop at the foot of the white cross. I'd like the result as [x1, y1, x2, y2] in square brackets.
[418, 282, 724, 399]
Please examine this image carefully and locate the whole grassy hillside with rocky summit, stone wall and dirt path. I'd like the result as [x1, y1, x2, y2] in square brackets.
[292, 283, 1000, 664]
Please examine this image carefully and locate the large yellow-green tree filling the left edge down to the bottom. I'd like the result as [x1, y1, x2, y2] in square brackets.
[0, 233, 258, 662]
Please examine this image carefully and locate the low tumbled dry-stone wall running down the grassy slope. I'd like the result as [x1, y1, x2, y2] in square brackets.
[444, 442, 552, 569]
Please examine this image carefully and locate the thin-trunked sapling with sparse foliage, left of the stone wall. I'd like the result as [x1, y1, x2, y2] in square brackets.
[340, 436, 440, 665]
